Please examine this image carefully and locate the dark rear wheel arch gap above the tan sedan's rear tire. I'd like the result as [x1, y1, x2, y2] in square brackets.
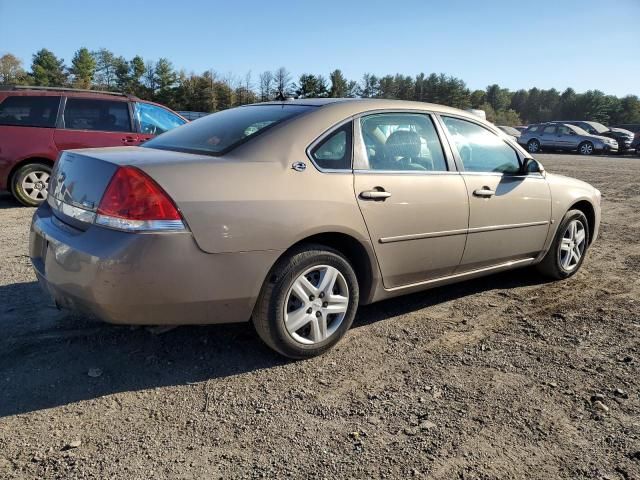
[266, 232, 377, 302]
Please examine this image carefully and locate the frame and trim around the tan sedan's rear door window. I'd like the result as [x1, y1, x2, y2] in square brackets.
[353, 108, 460, 175]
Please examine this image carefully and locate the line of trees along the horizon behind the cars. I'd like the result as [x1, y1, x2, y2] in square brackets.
[0, 48, 640, 125]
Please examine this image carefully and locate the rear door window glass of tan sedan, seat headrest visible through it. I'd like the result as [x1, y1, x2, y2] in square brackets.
[360, 113, 447, 171]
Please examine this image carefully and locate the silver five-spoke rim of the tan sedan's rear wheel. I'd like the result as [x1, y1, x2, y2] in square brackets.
[284, 265, 349, 345]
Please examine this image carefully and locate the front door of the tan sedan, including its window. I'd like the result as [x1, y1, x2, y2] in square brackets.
[442, 116, 551, 271]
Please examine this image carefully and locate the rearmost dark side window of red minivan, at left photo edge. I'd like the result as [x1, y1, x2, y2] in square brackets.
[0, 96, 60, 127]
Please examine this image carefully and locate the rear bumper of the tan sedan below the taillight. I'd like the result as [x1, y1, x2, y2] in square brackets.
[29, 203, 281, 325]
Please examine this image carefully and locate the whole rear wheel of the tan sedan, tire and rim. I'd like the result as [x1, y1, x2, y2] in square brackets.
[252, 245, 359, 359]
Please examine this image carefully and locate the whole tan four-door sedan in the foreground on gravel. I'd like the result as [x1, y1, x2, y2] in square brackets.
[29, 99, 600, 358]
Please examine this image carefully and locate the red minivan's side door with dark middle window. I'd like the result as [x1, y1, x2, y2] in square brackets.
[54, 97, 138, 150]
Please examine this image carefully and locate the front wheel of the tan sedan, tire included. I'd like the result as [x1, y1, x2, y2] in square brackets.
[537, 210, 589, 280]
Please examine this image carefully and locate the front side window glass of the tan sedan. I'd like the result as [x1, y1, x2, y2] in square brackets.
[442, 117, 520, 173]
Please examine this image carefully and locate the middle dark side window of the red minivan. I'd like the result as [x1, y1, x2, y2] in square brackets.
[64, 98, 131, 132]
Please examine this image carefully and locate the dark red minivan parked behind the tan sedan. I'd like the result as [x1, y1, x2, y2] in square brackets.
[0, 87, 187, 206]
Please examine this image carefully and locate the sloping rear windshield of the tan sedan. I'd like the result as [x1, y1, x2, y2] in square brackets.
[144, 104, 314, 155]
